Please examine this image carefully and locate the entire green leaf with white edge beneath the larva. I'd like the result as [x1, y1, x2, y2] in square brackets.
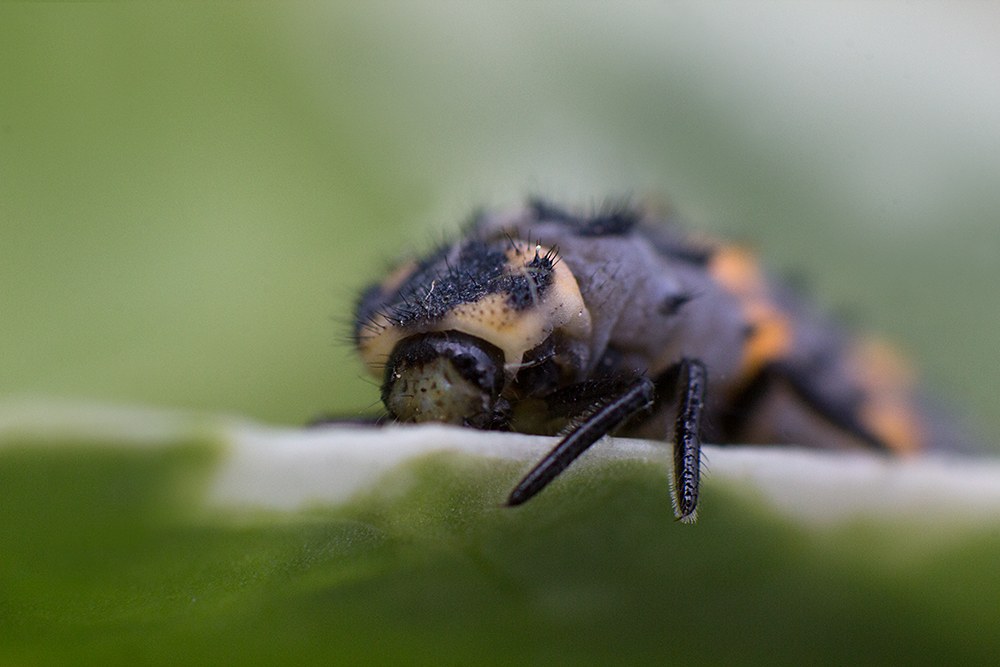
[0, 405, 1000, 665]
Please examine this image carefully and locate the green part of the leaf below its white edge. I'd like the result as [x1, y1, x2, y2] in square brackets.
[0, 440, 1000, 665]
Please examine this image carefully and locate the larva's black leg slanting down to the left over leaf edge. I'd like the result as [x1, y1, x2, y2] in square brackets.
[507, 377, 656, 507]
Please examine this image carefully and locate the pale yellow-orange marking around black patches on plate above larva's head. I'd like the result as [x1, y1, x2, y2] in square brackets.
[358, 241, 591, 378]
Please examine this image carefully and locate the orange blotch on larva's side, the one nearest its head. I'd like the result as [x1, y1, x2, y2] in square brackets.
[708, 246, 795, 380]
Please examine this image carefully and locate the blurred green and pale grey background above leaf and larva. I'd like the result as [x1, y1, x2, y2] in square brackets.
[0, 2, 1000, 444]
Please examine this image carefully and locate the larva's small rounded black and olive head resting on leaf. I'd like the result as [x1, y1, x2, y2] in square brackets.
[382, 331, 504, 428]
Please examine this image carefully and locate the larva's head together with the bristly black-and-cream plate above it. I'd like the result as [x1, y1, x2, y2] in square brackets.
[355, 237, 590, 426]
